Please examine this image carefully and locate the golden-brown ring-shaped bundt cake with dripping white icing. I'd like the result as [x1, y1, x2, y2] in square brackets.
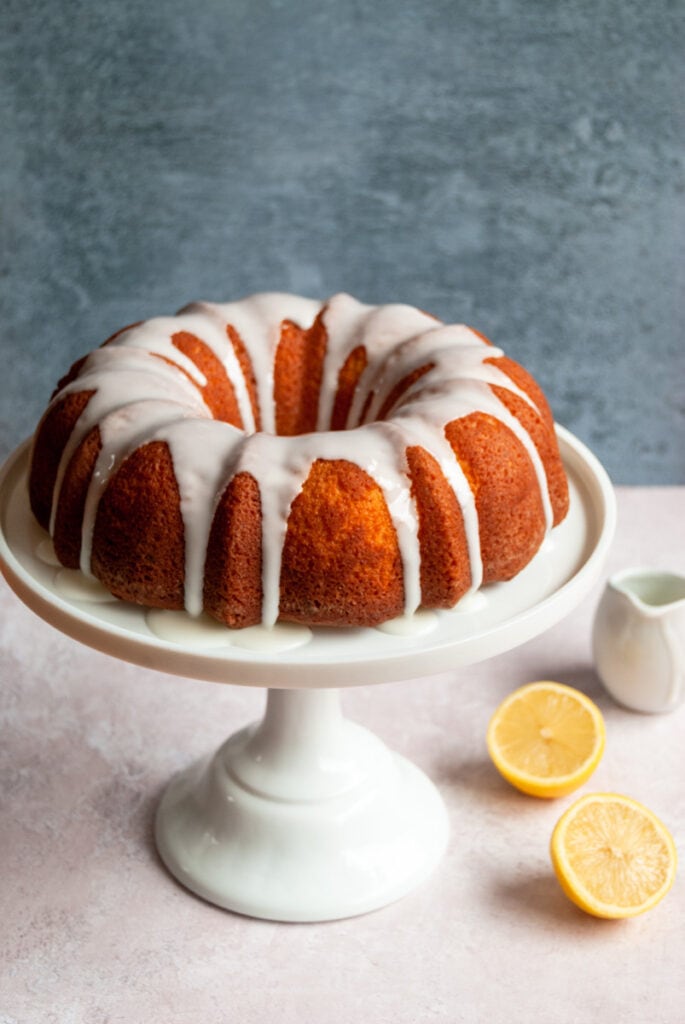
[29, 294, 568, 628]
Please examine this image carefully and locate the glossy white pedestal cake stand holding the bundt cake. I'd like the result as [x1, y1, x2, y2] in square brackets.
[0, 428, 615, 922]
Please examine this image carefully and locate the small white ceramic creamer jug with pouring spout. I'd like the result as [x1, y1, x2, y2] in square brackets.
[593, 569, 685, 713]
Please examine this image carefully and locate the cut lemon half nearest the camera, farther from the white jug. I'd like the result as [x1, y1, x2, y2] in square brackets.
[551, 793, 678, 918]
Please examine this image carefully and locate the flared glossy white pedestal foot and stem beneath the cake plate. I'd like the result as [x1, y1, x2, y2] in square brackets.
[156, 689, 447, 922]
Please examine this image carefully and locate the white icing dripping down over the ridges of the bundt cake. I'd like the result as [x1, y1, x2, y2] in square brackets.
[45, 293, 565, 627]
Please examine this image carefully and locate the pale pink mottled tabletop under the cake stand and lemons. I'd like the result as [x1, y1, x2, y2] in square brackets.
[0, 487, 685, 1024]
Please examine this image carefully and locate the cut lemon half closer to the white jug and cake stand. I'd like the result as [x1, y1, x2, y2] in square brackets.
[487, 682, 605, 797]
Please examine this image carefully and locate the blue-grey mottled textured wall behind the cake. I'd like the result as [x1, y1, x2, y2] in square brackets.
[0, 0, 685, 483]
